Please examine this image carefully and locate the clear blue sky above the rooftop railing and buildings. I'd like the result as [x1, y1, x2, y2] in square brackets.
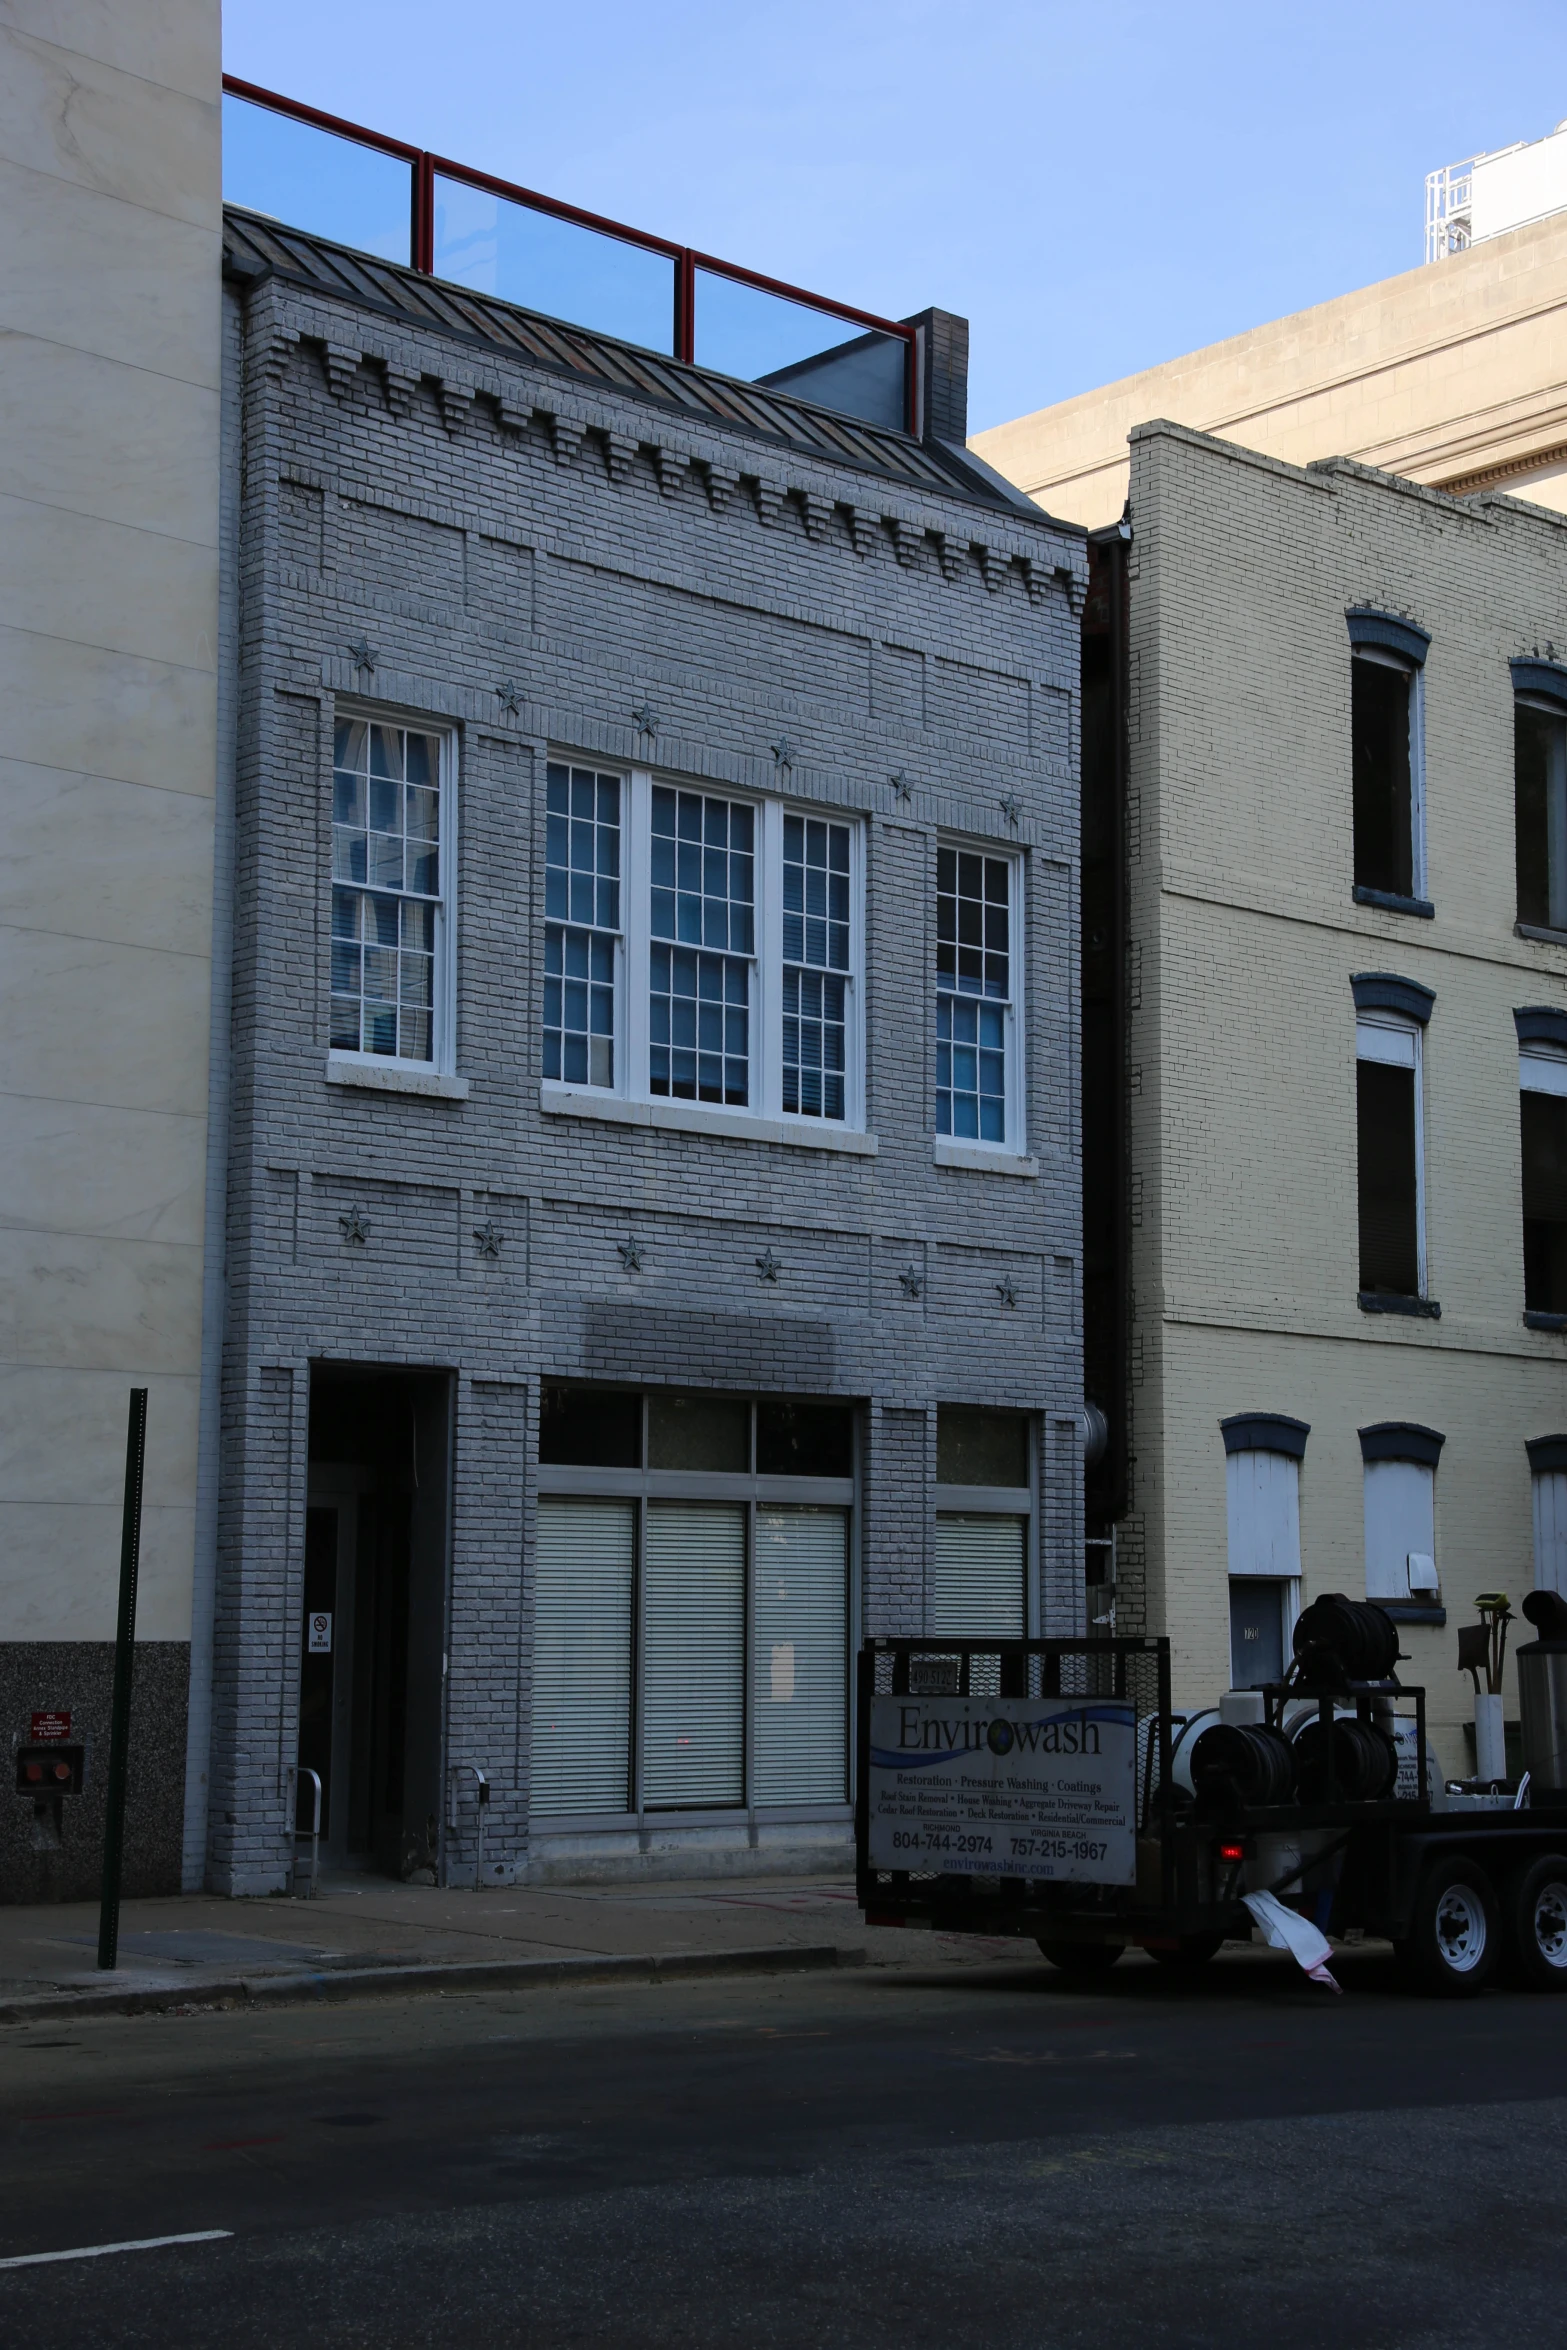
[223, 0, 1567, 430]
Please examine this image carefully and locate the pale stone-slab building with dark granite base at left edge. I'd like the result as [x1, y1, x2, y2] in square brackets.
[0, 0, 221, 1896]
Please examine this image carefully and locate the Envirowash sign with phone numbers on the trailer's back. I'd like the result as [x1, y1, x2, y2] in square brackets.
[867, 1697, 1137, 1885]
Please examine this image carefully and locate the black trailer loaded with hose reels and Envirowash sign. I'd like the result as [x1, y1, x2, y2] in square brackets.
[855, 1593, 1567, 1998]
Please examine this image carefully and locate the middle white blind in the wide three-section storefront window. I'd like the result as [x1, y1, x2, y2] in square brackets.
[641, 1502, 745, 1810]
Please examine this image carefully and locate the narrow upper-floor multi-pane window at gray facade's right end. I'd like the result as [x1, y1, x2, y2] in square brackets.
[935, 848, 1022, 1149]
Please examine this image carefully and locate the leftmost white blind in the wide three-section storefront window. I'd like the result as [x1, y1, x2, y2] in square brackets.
[531, 1495, 637, 1819]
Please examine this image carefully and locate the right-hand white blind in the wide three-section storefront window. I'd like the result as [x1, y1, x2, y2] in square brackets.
[752, 1509, 848, 1802]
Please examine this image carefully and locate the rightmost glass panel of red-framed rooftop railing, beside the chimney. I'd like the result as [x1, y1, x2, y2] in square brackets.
[695, 268, 907, 430]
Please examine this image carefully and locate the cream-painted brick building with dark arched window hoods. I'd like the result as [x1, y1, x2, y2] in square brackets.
[1104, 423, 1567, 1772]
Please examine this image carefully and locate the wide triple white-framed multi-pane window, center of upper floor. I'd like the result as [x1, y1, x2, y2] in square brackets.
[543, 761, 865, 1130]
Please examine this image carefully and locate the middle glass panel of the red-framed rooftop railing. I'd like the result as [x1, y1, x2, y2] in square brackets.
[435, 172, 674, 353]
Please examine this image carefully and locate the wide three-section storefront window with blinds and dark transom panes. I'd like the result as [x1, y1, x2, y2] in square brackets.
[531, 1387, 855, 1824]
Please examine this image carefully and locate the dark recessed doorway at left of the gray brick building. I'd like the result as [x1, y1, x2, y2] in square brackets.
[296, 1363, 451, 1880]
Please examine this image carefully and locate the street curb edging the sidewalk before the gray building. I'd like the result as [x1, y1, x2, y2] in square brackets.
[0, 1941, 865, 2023]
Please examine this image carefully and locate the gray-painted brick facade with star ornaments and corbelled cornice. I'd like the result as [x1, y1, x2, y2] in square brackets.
[209, 266, 1085, 1892]
